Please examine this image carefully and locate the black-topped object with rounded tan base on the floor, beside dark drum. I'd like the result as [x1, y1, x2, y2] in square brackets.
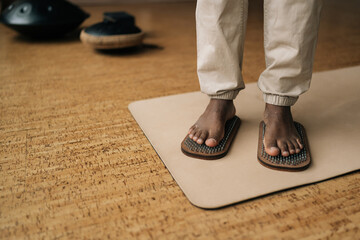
[80, 12, 144, 49]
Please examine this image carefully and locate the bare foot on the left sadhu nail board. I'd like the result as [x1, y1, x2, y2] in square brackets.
[189, 99, 235, 147]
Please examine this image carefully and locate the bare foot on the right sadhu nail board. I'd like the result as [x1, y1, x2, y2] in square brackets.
[264, 104, 303, 157]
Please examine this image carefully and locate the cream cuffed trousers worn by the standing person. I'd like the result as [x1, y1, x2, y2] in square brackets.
[196, 0, 322, 106]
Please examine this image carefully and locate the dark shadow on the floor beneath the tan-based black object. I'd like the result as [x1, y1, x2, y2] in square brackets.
[95, 43, 164, 56]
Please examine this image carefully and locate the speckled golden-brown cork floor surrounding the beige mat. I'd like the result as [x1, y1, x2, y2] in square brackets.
[0, 0, 360, 239]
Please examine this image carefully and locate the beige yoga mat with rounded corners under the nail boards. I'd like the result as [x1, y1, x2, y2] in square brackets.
[129, 66, 360, 208]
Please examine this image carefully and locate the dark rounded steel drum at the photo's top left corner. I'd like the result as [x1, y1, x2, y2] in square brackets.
[0, 0, 90, 37]
